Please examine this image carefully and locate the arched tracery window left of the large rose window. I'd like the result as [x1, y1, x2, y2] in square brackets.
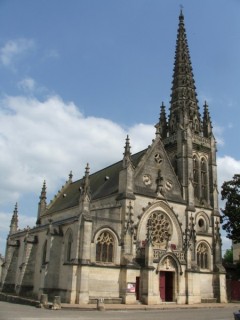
[96, 231, 114, 262]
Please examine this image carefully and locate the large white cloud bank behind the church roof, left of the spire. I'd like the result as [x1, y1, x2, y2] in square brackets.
[0, 94, 154, 203]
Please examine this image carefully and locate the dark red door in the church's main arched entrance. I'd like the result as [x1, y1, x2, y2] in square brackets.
[159, 271, 175, 302]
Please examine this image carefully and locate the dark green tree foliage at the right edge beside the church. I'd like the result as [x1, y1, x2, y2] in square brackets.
[221, 174, 240, 243]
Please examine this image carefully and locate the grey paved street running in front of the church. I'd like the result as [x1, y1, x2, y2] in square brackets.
[0, 301, 239, 320]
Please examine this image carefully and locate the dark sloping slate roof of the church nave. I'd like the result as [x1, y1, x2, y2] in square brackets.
[46, 149, 147, 214]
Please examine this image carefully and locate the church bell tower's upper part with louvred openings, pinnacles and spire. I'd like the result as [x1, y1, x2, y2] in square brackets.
[156, 10, 218, 212]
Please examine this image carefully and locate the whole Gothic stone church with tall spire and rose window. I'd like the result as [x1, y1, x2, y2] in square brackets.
[1, 11, 227, 305]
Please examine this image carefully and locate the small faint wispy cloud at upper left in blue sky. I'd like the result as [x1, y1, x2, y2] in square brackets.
[0, 38, 34, 67]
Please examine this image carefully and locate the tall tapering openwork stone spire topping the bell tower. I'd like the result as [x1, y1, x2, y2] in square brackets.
[169, 9, 201, 134]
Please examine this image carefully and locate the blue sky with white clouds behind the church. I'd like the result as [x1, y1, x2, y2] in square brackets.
[0, 0, 240, 255]
